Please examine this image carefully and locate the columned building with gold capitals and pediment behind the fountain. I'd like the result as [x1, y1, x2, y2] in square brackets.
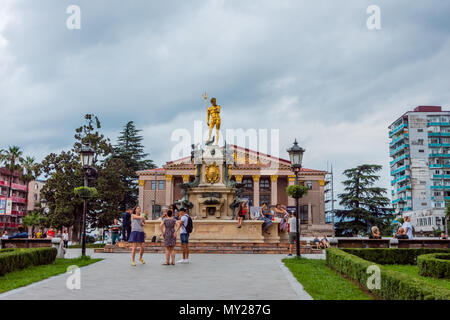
[138, 145, 333, 236]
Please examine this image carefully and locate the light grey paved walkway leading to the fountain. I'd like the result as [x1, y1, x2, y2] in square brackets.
[0, 249, 316, 300]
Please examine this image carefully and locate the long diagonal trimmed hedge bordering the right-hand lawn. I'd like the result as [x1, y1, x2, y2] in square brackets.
[326, 248, 450, 300]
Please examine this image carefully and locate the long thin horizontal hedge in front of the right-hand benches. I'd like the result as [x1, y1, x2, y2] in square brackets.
[341, 248, 450, 264]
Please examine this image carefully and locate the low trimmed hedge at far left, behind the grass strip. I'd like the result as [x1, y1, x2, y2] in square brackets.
[0, 248, 57, 276]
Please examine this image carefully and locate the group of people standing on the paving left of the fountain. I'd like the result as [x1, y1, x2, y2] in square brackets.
[123, 206, 193, 266]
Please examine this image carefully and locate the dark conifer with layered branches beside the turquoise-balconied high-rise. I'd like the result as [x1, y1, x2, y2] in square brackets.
[335, 164, 393, 236]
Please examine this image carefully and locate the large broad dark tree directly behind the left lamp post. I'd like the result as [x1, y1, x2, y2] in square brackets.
[41, 114, 124, 241]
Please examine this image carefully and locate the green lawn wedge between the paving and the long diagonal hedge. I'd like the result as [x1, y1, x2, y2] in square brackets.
[283, 258, 374, 300]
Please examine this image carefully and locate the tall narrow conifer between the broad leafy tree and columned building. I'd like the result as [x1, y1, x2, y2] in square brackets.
[114, 121, 156, 210]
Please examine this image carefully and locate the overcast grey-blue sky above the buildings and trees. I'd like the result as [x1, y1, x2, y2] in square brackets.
[0, 0, 450, 200]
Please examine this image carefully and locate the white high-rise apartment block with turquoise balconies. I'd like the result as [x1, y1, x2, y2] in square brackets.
[389, 106, 450, 233]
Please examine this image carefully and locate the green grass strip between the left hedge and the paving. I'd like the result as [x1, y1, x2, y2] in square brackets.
[0, 257, 103, 293]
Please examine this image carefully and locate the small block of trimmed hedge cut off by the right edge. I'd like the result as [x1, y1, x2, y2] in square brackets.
[417, 253, 450, 278]
